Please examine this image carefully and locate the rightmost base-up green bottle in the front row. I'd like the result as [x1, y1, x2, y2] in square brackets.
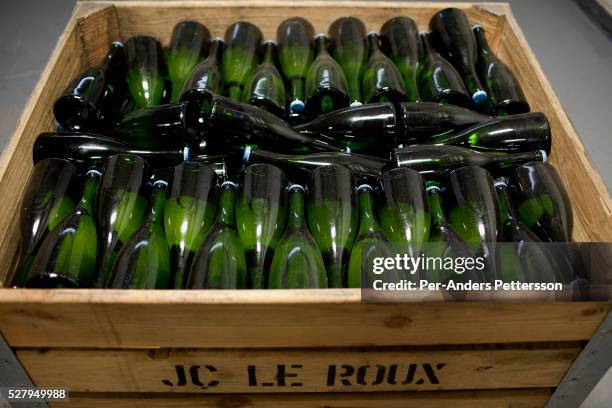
[510, 162, 573, 242]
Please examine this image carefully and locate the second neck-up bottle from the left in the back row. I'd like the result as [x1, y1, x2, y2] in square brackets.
[181, 37, 225, 100]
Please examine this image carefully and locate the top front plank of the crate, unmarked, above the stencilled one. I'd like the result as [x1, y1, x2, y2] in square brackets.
[0, 289, 610, 348]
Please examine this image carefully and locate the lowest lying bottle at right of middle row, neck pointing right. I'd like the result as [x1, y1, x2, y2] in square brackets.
[391, 145, 547, 175]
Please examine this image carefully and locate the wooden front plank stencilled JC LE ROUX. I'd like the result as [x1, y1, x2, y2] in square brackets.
[17, 344, 581, 393]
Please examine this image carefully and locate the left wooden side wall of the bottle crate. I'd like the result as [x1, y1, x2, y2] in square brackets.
[0, 20, 83, 287]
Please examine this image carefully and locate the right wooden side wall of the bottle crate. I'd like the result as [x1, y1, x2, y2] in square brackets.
[498, 15, 612, 242]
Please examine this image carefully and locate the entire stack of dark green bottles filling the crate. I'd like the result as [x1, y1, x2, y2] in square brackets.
[13, 8, 572, 288]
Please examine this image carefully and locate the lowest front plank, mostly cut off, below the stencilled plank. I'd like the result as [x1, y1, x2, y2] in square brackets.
[51, 389, 550, 408]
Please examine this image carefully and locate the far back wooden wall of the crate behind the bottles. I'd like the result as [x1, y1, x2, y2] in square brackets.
[116, 1, 506, 44]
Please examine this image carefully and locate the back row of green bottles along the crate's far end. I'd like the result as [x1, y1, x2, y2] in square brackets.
[54, 8, 529, 131]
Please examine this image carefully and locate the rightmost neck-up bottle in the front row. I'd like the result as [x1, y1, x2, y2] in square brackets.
[495, 177, 559, 282]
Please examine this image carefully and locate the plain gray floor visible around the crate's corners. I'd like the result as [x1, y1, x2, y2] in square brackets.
[0, 0, 612, 408]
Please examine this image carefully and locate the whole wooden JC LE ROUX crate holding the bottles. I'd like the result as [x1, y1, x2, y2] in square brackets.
[0, 1, 612, 407]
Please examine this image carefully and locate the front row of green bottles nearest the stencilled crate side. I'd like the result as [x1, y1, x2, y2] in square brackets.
[13, 151, 572, 289]
